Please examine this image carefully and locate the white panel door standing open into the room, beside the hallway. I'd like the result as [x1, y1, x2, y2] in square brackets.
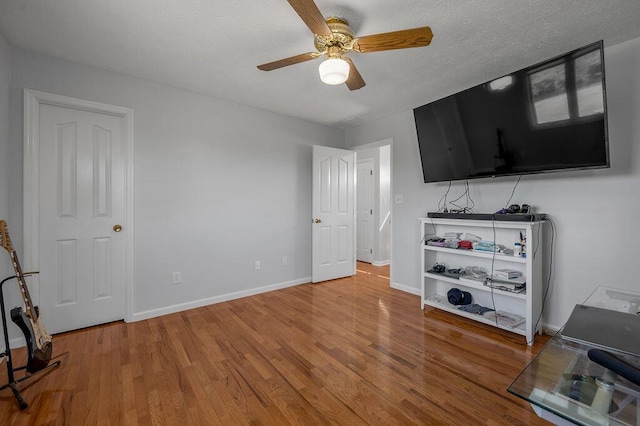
[311, 146, 356, 283]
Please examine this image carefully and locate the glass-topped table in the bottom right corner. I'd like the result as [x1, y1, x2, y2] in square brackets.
[507, 287, 640, 426]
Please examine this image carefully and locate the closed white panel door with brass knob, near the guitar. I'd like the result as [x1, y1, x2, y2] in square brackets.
[25, 91, 131, 333]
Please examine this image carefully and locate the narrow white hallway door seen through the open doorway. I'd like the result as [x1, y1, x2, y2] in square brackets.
[356, 159, 373, 263]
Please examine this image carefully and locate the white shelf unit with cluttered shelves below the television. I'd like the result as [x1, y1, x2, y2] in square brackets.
[420, 218, 544, 344]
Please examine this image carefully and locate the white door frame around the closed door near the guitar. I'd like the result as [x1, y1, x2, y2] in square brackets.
[23, 89, 134, 322]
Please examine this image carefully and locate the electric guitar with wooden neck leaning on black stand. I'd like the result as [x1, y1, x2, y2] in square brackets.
[0, 220, 53, 373]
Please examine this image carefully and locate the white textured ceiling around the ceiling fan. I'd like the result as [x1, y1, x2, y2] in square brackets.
[0, 0, 640, 128]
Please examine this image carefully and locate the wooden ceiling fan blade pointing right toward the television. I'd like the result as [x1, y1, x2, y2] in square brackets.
[353, 27, 433, 53]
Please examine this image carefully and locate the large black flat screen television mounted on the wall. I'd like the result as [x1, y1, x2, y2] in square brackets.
[413, 41, 609, 182]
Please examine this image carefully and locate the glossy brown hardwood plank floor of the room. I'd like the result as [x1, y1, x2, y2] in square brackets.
[0, 264, 547, 425]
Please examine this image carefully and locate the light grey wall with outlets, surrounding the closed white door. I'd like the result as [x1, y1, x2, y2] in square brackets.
[6, 49, 344, 326]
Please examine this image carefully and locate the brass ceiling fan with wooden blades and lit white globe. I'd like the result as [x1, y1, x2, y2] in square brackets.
[258, 0, 433, 90]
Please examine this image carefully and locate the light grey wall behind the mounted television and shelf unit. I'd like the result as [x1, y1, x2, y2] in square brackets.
[346, 39, 640, 328]
